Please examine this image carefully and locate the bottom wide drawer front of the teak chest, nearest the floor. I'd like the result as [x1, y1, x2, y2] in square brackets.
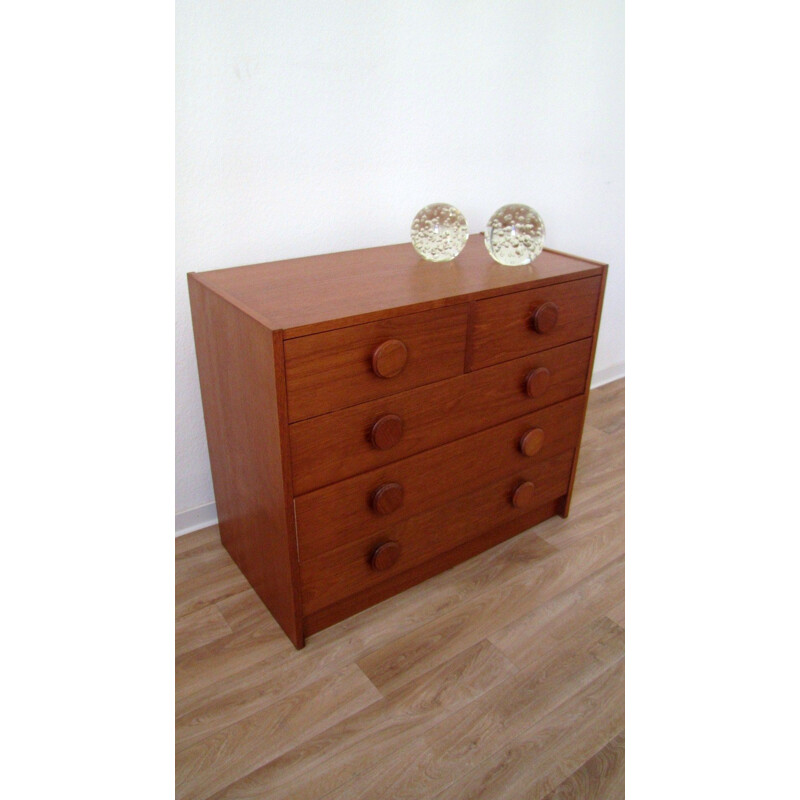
[300, 450, 574, 615]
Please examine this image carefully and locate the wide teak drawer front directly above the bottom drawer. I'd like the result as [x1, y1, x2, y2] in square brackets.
[295, 396, 584, 561]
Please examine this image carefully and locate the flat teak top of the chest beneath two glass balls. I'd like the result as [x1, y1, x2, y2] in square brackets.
[191, 234, 605, 338]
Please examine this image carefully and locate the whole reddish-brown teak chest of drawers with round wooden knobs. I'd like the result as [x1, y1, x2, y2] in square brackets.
[189, 235, 607, 647]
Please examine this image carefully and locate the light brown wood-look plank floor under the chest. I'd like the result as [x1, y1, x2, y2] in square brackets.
[175, 380, 625, 800]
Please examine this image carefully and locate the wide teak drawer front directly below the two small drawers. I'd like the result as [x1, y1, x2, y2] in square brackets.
[289, 339, 592, 494]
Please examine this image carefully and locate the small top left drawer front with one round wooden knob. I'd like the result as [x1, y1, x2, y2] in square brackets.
[284, 304, 467, 422]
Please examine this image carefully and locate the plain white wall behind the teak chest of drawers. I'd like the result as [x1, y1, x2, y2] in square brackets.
[176, 0, 625, 529]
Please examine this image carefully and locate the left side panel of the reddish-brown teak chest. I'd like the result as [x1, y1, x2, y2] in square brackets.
[189, 275, 303, 646]
